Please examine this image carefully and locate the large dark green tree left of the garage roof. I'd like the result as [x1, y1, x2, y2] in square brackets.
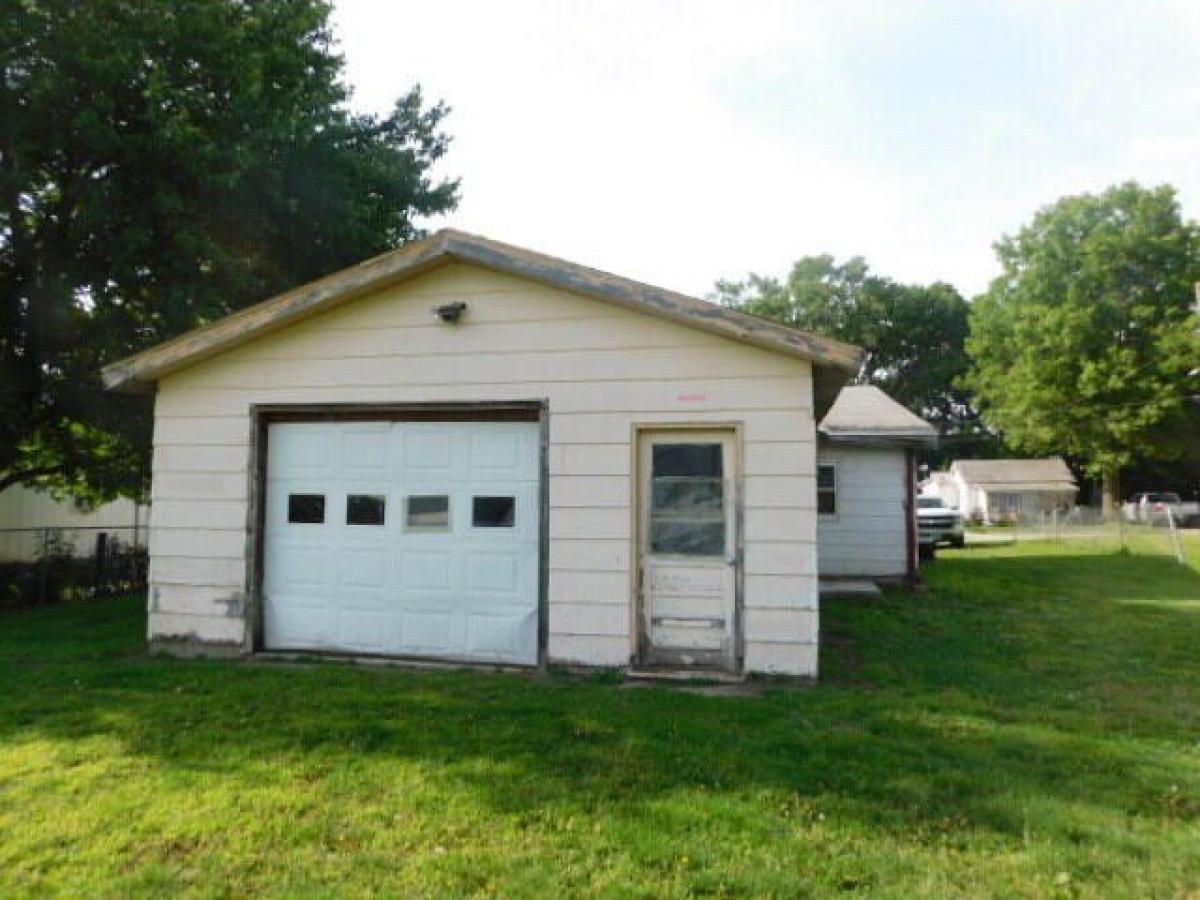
[0, 0, 457, 498]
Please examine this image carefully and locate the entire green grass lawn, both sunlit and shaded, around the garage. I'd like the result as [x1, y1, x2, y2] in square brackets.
[0, 541, 1200, 898]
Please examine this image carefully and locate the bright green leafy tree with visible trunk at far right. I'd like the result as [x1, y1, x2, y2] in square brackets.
[966, 184, 1200, 514]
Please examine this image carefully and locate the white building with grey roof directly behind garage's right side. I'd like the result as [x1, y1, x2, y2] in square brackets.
[817, 385, 937, 578]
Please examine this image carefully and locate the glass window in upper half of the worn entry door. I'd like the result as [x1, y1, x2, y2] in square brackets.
[649, 444, 726, 556]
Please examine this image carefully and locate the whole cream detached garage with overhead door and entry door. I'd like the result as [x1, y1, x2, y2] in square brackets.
[104, 230, 859, 676]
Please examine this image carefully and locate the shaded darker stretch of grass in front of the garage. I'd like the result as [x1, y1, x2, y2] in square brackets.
[0, 553, 1200, 868]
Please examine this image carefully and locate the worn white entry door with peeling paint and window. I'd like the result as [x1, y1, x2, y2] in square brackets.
[638, 431, 737, 671]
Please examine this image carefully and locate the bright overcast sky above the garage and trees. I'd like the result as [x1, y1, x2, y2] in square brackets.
[334, 0, 1200, 301]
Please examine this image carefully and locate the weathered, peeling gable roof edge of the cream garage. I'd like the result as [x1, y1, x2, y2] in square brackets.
[102, 228, 862, 390]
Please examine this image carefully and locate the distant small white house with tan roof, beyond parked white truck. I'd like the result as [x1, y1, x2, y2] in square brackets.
[922, 456, 1079, 523]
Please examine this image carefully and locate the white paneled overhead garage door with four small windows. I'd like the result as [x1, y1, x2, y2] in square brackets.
[263, 422, 539, 665]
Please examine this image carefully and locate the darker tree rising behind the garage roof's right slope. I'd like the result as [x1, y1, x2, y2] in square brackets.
[715, 256, 979, 438]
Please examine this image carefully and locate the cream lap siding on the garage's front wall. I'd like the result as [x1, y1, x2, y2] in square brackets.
[150, 264, 816, 673]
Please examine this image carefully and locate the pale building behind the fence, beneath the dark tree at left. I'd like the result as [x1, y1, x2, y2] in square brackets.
[0, 485, 150, 563]
